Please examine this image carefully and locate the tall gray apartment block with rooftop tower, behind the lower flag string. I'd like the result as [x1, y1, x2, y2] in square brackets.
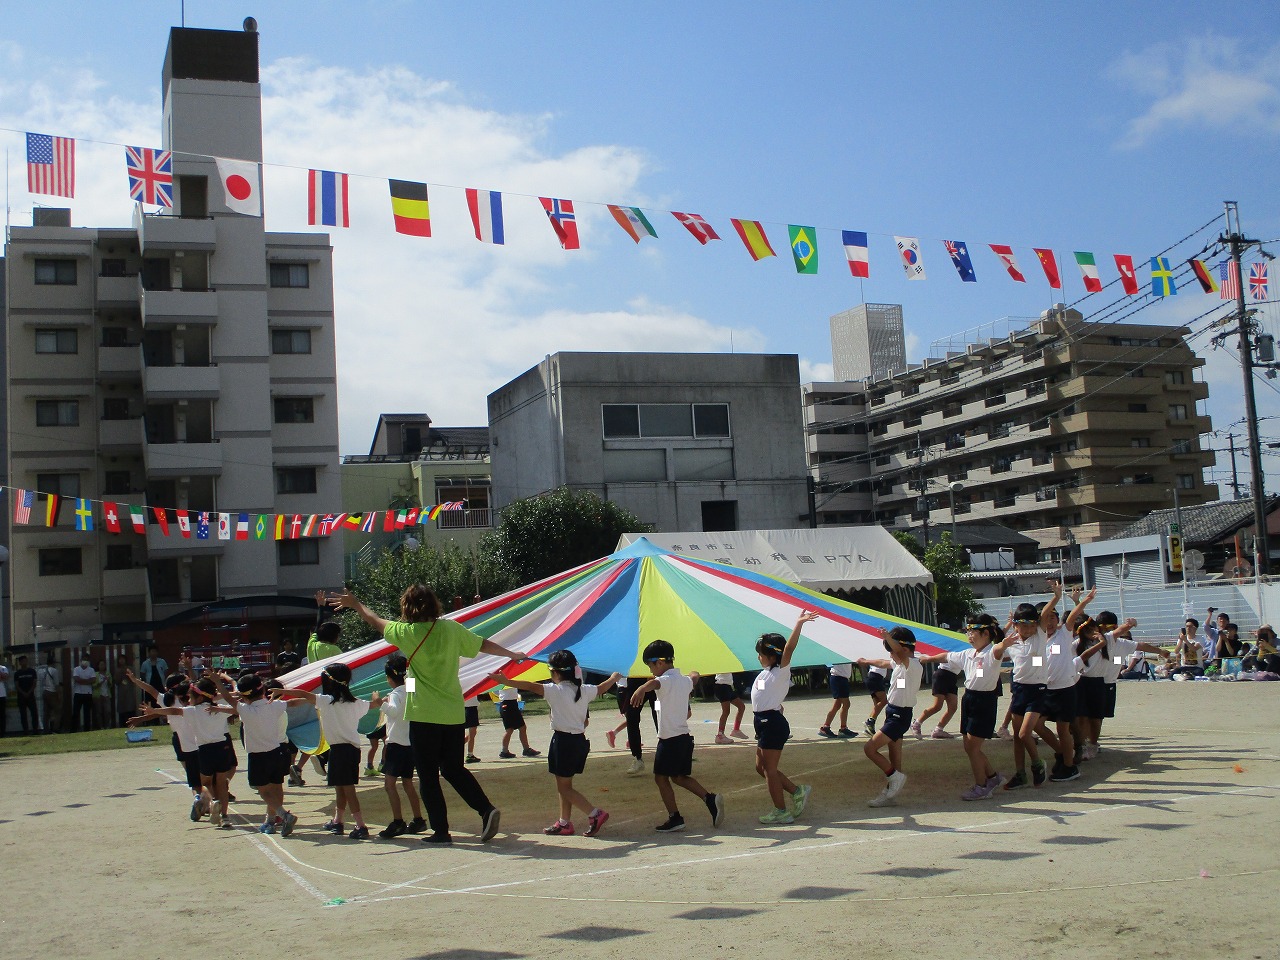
[6, 28, 342, 643]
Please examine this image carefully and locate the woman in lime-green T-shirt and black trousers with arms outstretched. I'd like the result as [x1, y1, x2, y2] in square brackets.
[329, 584, 524, 844]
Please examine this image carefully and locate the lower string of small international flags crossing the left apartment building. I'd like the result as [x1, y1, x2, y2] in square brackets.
[0, 486, 466, 540]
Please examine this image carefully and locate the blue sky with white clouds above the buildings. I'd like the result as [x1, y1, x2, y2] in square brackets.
[0, 0, 1280, 489]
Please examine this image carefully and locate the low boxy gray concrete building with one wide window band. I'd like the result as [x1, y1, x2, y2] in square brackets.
[489, 353, 808, 532]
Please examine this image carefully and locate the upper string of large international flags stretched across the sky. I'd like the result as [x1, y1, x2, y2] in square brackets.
[27, 133, 1268, 302]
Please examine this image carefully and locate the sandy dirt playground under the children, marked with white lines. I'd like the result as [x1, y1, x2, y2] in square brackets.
[0, 682, 1280, 960]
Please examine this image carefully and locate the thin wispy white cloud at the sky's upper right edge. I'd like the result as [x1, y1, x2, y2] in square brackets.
[1110, 37, 1280, 150]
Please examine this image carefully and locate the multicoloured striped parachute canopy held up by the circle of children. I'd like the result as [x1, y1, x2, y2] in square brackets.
[282, 539, 965, 749]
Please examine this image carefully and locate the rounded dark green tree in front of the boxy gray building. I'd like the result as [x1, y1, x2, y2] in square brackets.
[480, 486, 649, 590]
